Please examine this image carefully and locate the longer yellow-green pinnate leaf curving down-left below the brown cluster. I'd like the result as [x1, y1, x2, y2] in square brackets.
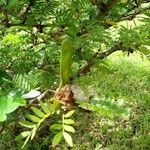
[16, 99, 60, 148]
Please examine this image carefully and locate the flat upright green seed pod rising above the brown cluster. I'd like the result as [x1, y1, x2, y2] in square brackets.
[60, 39, 73, 88]
